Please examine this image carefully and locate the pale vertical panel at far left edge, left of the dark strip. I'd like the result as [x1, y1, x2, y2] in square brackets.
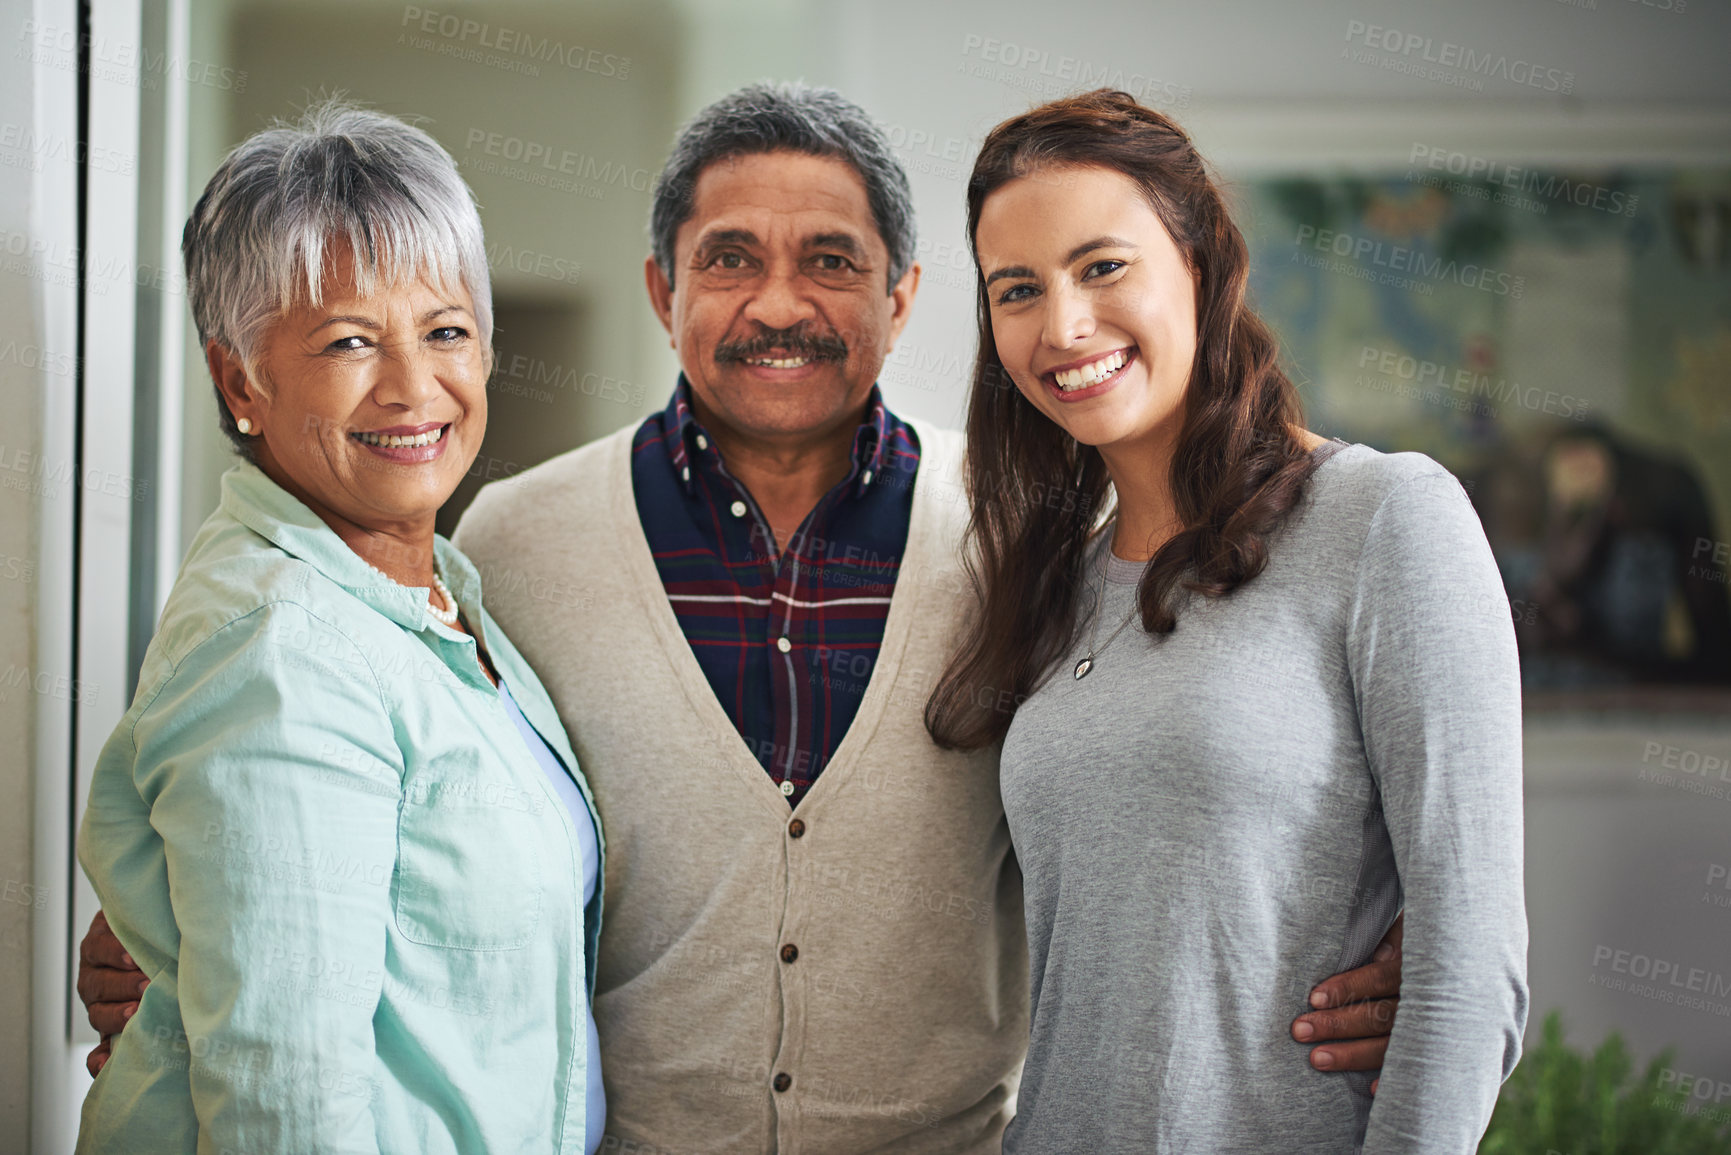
[0, 0, 78, 1150]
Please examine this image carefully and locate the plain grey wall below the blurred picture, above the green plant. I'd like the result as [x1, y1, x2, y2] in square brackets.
[1527, 713, 1731, 1082]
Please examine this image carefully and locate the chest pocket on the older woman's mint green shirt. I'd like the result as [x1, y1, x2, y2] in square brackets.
[396, 750, 547, 951]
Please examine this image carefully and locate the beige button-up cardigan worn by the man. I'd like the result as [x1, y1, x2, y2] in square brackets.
[457, 423, 1028, 1155]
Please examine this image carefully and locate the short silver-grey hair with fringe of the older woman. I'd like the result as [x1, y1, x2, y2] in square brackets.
[180, 100, 493, 457]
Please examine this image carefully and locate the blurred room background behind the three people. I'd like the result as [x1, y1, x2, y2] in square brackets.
[0, 0, 1731, 1152]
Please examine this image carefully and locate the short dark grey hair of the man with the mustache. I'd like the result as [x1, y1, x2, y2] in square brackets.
[649, 83, 914, 291]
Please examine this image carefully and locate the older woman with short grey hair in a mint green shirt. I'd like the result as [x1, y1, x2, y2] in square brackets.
[78, 104, 604, 1155]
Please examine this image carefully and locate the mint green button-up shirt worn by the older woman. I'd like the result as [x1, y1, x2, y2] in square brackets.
[78, 466, 601, 1155]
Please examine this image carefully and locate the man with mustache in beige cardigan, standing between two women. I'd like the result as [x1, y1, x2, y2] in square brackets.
[87, 85, 1399, 1155]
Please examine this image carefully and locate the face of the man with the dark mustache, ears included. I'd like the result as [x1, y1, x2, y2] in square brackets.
[644, 152, 919, 445]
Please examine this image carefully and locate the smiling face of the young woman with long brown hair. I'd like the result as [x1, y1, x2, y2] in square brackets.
[975, 166, 1196, 450]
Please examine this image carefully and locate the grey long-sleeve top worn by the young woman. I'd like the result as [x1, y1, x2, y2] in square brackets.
[1002, 445, 1527, 1155]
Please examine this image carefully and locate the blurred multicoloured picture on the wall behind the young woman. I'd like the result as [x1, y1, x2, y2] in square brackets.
[1236, 167, 1731, 689]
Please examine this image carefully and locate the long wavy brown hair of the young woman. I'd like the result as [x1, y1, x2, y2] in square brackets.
[926, 88, 1316, 750]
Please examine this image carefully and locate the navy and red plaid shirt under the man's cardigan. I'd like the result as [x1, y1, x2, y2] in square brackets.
[632, 376, 919, 805]
